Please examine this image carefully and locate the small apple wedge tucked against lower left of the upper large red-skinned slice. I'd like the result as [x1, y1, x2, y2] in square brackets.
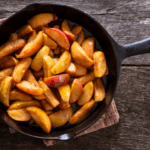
[43, 33, 57, 49]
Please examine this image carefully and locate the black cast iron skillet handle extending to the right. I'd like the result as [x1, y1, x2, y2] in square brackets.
[120, 38, 150, 62]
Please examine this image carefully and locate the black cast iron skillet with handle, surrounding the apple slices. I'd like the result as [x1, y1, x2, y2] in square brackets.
[0, 3, 150, 140]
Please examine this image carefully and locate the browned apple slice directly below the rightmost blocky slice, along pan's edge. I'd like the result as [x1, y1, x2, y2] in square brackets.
[94, 78, 105, 102]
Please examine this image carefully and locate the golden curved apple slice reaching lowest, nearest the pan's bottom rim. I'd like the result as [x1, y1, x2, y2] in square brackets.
[26, 106, 51, 134]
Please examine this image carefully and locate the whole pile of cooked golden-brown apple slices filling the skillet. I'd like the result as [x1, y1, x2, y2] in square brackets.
[0, 13, 109, 134]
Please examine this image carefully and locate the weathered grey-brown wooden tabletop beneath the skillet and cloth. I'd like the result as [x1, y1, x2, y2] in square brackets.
[0, 0, 150, 150]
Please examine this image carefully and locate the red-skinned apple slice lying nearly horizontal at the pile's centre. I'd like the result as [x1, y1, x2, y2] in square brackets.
[44, 74, 70, 87]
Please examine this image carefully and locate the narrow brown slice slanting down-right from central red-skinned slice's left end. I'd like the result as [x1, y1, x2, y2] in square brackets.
[39, 81, 59, 108]
